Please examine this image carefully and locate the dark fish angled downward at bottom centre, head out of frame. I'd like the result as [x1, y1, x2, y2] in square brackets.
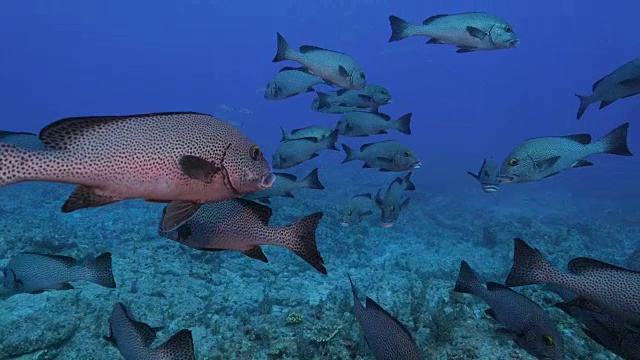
[349, 277, 424, 360]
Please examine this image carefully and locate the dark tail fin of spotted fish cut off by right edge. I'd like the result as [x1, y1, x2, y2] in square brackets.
[505, 239, 559, 286]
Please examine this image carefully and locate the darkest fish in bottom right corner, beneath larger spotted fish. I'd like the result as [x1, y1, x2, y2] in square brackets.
[555, 298, 640, 360]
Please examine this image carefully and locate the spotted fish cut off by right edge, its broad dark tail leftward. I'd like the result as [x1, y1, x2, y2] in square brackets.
[505, 238, 640, 329]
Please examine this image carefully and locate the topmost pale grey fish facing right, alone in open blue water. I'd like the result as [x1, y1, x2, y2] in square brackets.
[389, 12, 520, 53]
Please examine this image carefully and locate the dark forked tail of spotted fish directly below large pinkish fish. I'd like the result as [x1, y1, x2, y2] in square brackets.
[279, 212, 327, 275]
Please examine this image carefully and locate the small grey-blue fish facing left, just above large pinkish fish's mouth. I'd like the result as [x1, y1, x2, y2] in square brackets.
[271, 131, 338, 169]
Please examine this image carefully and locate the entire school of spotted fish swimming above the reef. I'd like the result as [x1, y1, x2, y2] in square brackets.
[0, 6, 640, 360]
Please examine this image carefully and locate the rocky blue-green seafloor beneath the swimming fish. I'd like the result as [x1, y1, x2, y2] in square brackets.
[0, 161, 640, 360]
